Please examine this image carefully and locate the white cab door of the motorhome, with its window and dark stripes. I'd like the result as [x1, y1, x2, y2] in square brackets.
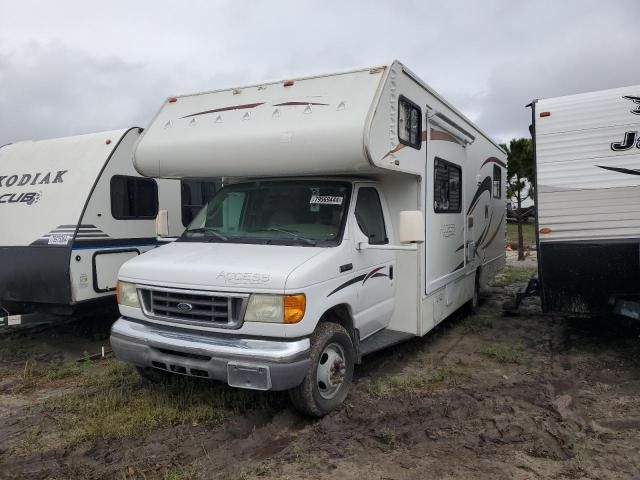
[350, 184, 396, 339]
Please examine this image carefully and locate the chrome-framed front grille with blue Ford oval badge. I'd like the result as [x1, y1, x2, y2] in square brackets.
[138, 287, 248, 328]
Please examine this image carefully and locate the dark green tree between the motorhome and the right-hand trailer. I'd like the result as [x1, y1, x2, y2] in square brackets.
[502, 138, 534, 260]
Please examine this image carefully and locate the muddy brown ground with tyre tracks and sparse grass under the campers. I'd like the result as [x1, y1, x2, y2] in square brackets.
[0, 270, 640, 480]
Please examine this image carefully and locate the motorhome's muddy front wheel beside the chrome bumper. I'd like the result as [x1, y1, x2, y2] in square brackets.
[289, 322, 355, 417]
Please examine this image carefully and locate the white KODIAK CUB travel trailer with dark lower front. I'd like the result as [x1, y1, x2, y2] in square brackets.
[0, 128, 220, 325]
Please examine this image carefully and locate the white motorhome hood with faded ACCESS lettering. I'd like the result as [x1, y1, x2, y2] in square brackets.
[118, 242, 326, 291]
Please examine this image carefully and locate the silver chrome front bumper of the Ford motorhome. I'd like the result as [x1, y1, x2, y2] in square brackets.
[111, 317, 311, 390]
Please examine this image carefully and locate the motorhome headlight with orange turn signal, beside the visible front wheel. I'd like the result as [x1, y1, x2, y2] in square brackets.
[244, 294, 306, 323]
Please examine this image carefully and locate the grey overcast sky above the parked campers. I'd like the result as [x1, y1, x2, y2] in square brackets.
[0, 0, 640, 145]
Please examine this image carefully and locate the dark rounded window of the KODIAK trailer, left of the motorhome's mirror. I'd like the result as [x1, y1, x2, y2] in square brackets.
[111, 175, 158, 220]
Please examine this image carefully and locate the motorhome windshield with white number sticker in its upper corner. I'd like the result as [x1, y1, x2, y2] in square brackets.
[180, 180, 351, 246]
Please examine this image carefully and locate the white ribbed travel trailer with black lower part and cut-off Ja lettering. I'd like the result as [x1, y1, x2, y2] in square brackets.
[532, 85, 640, 318]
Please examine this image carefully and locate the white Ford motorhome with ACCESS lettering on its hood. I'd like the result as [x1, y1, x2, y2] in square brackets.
[111, 62, 506, 416]
